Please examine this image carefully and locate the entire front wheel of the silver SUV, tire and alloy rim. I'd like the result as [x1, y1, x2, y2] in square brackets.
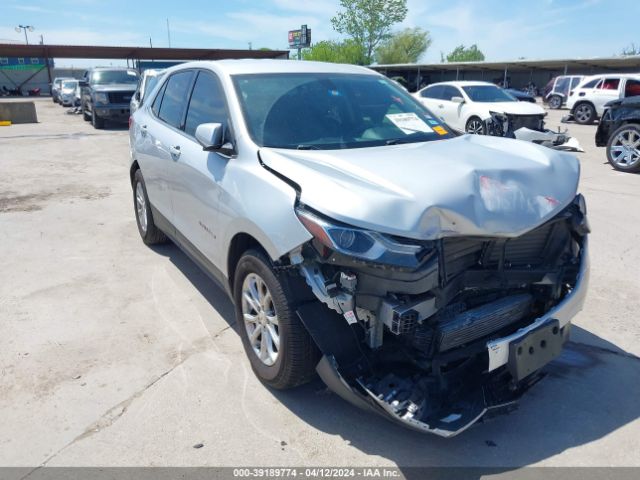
[233, 250, 320, 389]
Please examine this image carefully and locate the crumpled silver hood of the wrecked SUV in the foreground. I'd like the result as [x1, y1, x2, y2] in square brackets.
[259, 135, 580, 239]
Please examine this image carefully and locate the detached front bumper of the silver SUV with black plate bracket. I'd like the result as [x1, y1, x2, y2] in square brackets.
[298, 236, 589, 437]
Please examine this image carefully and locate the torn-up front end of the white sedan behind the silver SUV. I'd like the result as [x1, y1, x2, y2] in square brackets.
[484, 112, 584, 152]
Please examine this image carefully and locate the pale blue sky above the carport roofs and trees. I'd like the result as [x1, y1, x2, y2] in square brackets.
[0, 0, 640, 64]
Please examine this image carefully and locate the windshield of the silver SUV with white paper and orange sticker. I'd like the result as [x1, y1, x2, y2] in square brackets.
[233, 73, 452, 149]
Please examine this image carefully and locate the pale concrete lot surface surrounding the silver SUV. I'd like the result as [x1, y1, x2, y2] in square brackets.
[0, 98, 640, 467]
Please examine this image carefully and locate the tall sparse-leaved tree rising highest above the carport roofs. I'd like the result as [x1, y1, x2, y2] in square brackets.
[331, 0, 407, 64]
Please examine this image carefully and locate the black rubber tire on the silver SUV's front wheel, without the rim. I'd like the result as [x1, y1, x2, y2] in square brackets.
[233, 250, 320, 389]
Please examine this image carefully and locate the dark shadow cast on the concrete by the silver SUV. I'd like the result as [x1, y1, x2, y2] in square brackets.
[154, 240, 640, 472]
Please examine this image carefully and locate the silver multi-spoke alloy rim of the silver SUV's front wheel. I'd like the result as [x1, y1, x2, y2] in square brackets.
[242, 273, 280, 366]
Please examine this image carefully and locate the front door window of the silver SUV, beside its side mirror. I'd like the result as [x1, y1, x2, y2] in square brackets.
[184, 72, 228, 136]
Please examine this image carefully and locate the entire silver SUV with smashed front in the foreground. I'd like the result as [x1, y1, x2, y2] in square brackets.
[129, 60, 589, 436]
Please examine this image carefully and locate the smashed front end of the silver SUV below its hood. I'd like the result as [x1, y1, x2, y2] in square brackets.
[289, 195, 589, 437]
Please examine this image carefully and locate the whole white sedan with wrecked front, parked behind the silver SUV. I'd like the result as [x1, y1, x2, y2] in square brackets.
[414, 81, 582, 151]
